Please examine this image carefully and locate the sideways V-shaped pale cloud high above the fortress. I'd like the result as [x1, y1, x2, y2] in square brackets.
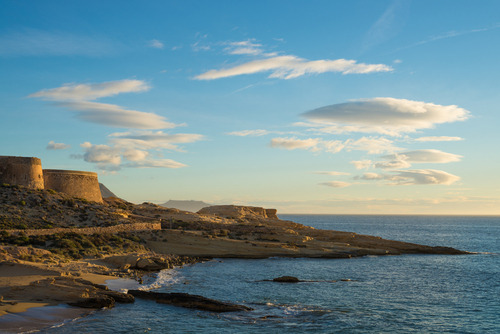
[28, 80, 179, 129]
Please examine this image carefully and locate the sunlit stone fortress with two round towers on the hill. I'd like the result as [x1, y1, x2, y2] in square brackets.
[0, 156, 103, 203]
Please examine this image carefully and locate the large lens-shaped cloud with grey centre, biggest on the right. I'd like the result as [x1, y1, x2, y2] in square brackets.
[302, 97, 470, 136]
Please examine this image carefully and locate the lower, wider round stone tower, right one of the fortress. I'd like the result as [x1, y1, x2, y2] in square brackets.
[43, 169, 102, 203]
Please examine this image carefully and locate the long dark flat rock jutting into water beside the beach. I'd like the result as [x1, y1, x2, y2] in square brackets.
[128, 290, 253, 312]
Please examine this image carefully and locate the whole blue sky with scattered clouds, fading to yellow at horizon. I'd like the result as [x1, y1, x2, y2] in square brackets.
[0, 0, 500, 214]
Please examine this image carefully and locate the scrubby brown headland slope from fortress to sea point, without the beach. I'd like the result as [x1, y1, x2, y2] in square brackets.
[0, 185, 468, 258]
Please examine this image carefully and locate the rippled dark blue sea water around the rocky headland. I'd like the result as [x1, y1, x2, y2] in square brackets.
[42, 215, 500, 333]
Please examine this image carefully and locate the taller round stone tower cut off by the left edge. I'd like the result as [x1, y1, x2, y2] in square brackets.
[0, 156, 44, 189]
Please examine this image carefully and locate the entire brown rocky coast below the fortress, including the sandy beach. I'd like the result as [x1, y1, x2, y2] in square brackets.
[0, 185, 467, 332]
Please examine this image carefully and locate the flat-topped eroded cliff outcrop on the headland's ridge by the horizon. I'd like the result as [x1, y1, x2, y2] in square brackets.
[198, 205, 278, 219]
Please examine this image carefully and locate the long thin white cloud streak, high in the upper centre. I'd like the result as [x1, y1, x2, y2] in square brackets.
[195, 55, 392, 80]
